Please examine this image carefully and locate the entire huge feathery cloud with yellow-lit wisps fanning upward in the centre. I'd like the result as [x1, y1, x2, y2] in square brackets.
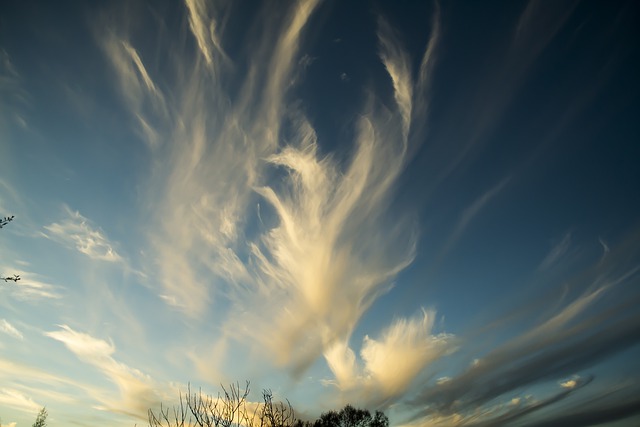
[106, 1, 438, 394]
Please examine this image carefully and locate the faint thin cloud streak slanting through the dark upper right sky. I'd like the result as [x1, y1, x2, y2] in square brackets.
[416, 1, 584, 188]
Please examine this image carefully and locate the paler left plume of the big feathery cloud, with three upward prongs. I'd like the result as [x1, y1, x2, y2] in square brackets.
[89, 0, 317, 315]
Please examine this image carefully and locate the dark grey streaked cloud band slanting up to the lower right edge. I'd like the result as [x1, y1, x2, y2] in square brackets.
[411, 253, 640, 425]
